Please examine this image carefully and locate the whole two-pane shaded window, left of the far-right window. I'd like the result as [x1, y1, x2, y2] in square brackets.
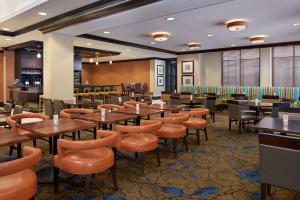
[222, 49, 260, 86]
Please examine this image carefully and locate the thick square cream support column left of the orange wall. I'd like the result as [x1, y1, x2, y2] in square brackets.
[43, 33, 74, 100]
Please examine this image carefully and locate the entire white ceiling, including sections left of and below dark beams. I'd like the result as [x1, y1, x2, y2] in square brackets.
[0, 0, 300, 60]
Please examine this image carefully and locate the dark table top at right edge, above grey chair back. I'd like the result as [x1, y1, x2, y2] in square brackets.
[253, 117, 300, 135]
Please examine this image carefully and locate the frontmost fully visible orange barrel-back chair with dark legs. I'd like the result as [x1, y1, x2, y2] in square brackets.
[54, 130, 119, 192]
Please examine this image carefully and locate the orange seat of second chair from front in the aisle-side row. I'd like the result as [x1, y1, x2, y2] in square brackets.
[120, 133, 158, 152]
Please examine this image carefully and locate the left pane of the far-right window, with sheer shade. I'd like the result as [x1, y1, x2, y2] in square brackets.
[273, 46, 294, 87]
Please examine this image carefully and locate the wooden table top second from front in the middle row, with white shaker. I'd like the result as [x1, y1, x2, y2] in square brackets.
[73, 111, 135, 124]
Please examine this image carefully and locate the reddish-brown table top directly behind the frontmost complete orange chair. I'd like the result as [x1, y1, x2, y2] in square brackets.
[18, 118, 96, 137]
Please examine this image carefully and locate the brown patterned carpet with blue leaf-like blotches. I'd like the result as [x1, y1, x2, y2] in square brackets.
[1, 112, 300, 200]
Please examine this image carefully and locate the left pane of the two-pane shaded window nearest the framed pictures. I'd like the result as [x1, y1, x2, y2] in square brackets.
[223, 50, 241, 86]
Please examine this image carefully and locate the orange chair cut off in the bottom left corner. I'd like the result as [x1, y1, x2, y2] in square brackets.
[0, 147, 41, 200]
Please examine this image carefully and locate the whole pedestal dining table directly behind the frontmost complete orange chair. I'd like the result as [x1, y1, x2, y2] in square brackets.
[18, 118, 97, 184]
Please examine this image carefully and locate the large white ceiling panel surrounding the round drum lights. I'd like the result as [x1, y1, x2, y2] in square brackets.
[59, 0, 300, 51]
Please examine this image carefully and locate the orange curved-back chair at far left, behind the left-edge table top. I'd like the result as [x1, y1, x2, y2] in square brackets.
[6, 113, 52, 154]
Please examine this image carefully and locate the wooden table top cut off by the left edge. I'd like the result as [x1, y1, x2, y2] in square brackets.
[0, 128, 31, 147]
